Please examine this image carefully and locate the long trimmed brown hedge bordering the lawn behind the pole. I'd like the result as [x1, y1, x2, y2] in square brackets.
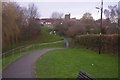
[75, 34, 120, 54]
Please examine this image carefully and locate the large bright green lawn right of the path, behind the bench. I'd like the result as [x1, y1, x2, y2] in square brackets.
[36, 48, 118, 78]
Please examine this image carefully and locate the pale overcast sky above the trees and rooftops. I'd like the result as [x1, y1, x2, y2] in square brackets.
[5, 0, 120, 19]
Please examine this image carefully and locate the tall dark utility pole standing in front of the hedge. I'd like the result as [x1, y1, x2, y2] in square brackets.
[99, 0, 103, 54]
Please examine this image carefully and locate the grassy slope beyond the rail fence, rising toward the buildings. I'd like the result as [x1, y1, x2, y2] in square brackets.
[2, 27, 62, 52]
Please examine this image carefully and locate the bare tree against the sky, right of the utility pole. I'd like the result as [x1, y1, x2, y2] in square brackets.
[104, 5, 119, 34]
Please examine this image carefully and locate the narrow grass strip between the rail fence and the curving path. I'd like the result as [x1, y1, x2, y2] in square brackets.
[0, 42, 63, 69]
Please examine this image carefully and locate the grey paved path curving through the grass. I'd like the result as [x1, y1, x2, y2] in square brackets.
[2, 48, 63, 78]
